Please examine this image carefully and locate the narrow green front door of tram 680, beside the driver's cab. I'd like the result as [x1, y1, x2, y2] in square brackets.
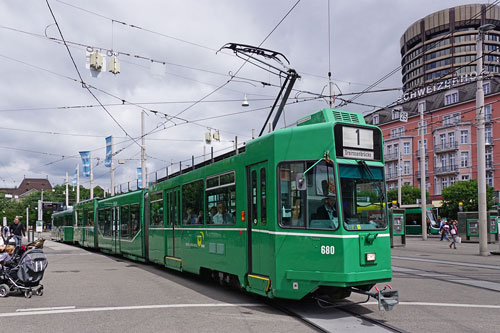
[247, 162, 272, 276]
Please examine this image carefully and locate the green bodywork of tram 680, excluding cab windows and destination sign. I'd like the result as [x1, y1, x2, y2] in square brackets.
[51, 109, 392, 299]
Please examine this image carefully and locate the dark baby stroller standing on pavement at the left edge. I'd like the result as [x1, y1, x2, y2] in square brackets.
[0, 235, 48, 298]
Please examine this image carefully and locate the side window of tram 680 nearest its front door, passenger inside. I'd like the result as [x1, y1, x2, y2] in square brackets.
[206, 171, 236, 224]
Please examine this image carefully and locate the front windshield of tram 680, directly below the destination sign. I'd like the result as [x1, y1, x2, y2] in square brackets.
[339, 164, 387, 230]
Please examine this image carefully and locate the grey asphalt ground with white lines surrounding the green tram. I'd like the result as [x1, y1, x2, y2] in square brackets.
[0, 238, 500, 332]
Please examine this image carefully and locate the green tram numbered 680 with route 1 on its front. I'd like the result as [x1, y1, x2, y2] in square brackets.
[48, 109, 397, 304]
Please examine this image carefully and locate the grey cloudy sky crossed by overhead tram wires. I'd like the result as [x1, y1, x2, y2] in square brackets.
[0, 0, 486, 189]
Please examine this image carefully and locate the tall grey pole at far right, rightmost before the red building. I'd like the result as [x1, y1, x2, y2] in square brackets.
[476, 24, 495, 256]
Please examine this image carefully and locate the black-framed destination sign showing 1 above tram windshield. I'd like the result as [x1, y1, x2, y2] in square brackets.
[335, 124, 381, 160]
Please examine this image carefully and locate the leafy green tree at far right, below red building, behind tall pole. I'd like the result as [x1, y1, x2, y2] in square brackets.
[440, 179, 495, 219]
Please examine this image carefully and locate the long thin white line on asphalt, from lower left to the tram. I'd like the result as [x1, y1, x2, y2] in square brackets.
[0, 303, 266, 317]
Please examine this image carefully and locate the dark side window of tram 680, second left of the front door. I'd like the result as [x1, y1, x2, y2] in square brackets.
[182, 179, 203, 224]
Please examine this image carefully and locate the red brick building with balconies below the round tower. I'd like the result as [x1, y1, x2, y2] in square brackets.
[366, 76, 500, 196]
